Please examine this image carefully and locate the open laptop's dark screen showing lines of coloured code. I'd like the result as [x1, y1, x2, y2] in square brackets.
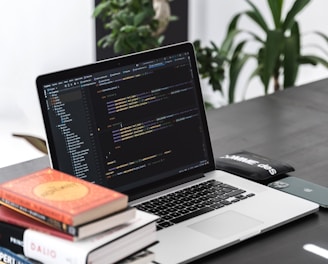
[37, 43, 214, 194]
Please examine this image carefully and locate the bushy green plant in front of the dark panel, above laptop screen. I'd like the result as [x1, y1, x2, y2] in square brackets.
[93, 0, 175, 54]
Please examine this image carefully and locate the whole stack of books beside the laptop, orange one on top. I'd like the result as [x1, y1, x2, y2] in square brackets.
[0, 168, 157, 264]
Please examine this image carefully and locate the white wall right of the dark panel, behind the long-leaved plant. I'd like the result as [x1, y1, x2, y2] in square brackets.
[189, 0, 328, 105]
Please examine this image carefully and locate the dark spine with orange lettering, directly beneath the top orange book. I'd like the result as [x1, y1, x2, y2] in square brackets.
[0, 198, 78, 237]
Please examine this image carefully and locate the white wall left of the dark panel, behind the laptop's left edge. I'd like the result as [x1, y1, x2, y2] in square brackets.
[0, 0, 95, 167]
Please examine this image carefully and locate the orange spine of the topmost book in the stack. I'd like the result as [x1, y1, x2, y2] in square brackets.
[0, 188, 73, 225]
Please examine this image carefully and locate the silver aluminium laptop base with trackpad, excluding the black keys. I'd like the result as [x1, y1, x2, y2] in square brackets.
[131, 171, 318, 264]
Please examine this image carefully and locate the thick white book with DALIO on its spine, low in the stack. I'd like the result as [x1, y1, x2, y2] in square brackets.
[23, 210, 158, 264]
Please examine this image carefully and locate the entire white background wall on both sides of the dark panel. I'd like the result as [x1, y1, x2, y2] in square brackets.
[0, 0, 328, 167]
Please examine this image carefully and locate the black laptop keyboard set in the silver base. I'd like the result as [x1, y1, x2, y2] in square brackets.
[135, 180, 254, 230]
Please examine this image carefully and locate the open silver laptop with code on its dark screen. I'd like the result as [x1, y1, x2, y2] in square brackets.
[37, 42, 318, 264]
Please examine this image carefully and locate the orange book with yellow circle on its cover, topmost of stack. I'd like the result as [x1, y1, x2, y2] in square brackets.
[0, 168, 128, 226]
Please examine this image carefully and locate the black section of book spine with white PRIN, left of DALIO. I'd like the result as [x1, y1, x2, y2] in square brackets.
[0, 222, 26, 254]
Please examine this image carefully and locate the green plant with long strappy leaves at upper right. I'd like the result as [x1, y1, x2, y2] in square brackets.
[195, 0, 328, 103]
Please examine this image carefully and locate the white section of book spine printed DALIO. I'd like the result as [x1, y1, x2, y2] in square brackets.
[23, 229, 89, 264]
